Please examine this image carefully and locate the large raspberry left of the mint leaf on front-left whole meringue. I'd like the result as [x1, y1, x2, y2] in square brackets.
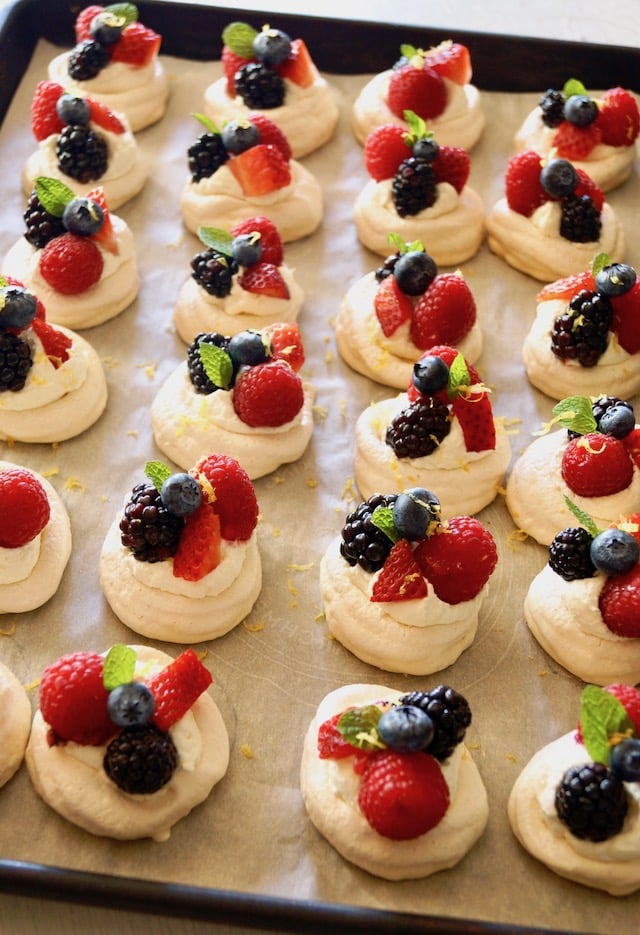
[40, 652, 118, 746]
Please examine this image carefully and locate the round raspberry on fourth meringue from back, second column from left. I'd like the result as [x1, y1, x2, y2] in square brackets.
[233, 359, 304, 428]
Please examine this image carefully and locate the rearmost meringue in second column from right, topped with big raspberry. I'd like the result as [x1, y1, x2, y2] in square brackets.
[351, 40, 485, 150]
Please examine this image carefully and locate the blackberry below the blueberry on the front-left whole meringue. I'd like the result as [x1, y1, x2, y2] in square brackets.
[102, 724, 178, 795]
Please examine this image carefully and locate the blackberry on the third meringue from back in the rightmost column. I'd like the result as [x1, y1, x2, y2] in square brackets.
[551, 289, 613, 367]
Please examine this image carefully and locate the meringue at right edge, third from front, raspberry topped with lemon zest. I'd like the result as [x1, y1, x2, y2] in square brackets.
[506, 396, 640, 546]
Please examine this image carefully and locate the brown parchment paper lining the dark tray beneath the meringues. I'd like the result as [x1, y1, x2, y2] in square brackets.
[0, 31, 640, 932]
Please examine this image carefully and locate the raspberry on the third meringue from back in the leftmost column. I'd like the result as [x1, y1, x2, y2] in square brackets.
[40, 234, 104, 295]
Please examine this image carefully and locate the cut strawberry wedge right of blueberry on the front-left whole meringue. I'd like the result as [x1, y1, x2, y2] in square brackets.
[146, 649, 213, 731]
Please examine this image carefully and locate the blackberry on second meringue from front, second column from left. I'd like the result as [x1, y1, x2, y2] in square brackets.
[120, 483, 184, 562]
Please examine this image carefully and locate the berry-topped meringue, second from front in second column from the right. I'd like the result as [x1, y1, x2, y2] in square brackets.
[320, 487, 498, 675]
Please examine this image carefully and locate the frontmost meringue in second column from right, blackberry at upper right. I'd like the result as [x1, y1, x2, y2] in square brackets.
[300, 684, 489, 880]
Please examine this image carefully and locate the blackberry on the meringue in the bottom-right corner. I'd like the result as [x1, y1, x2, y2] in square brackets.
[555, 763, 628, 841]
